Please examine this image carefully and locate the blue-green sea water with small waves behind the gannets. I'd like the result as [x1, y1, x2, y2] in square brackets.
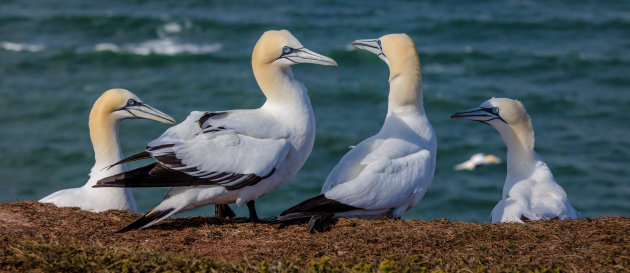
[0, 0, 630, 222]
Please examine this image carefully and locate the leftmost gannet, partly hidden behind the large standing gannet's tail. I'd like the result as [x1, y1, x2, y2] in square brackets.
[39, 89, 175, 212]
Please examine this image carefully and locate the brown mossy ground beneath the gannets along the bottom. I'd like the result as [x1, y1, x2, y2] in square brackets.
[0, 202, 630, 272]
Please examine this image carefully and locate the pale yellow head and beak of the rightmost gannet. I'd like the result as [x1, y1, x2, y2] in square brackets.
[451, 98, 534, 149]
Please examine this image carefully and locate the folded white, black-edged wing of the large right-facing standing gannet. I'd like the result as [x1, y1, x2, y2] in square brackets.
[98, 109, 290, 190]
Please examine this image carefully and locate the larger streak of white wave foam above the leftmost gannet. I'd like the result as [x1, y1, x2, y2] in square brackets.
[94, 38, 222, 56]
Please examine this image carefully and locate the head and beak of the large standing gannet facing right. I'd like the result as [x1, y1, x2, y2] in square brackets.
[252, 30, 337, 67]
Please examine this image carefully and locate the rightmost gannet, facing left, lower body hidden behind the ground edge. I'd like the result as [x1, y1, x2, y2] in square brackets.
[451, 98, 578, 223]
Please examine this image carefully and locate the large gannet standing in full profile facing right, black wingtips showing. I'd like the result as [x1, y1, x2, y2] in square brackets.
[96, 30, 337, 232]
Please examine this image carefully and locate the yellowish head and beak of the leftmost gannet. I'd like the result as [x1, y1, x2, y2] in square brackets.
[90, 89, 176, 124]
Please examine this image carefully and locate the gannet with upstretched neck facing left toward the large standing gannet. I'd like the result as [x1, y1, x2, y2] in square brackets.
[278, 34, 437, 232]
